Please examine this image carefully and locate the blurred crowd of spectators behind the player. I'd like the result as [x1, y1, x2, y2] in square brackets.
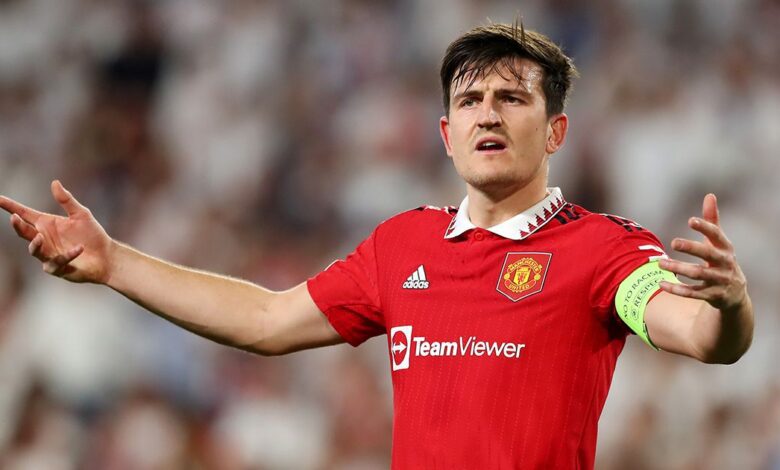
[0, 0, 780, 469]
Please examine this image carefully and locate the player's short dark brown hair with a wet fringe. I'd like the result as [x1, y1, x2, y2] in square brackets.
[440, 23, 578, 116]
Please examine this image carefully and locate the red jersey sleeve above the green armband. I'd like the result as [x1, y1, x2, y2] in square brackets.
[591, 220, 666, 326]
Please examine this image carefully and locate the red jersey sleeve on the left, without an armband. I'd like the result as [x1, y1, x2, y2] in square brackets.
[306, 231, 386, 346]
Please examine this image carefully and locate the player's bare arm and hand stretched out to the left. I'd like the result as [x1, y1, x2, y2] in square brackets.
[0, 181, 342, 355]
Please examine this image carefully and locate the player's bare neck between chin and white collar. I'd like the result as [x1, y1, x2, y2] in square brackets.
[467, 178, 547, 228]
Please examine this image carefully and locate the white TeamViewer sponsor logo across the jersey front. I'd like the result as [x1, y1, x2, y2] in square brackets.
[390, 325, 525, 371]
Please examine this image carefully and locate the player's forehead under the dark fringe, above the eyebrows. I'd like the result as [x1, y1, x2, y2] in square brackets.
[451, 58, 544, 95]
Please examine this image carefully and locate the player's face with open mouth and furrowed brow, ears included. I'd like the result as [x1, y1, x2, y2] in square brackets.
[439, 59, 568, 197]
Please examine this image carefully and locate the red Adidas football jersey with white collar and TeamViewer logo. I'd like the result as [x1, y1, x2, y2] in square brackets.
[308, 188, 663, 469]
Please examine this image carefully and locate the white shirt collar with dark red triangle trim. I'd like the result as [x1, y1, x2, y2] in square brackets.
[444, 188, 566, 240]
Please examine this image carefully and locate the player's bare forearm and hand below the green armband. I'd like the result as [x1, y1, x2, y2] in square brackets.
[645, 194, 753, 364]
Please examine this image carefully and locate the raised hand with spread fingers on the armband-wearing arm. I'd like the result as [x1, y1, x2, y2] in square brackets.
[659, 194, 749, 311]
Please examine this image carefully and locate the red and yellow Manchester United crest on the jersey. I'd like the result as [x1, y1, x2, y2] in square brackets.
[496, 252, 552, 302]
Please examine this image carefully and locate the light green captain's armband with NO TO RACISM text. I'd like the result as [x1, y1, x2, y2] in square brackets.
[615, 261, 680, 351]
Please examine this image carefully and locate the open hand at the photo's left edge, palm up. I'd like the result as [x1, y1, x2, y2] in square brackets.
[0, 181, 113, 283]
